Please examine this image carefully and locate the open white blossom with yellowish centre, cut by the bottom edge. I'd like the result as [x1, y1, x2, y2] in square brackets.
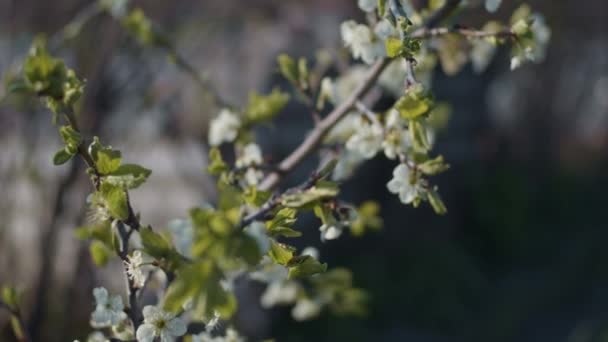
[137, 305, 187, 342]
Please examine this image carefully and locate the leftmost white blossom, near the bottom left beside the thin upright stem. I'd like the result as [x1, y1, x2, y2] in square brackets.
[91, 287, 127, 328]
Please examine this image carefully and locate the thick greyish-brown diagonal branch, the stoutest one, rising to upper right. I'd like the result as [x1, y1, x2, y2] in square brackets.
[260, 0, 460, 191]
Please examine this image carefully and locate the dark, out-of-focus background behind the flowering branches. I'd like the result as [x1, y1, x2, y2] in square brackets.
[0, 0, 608, 342]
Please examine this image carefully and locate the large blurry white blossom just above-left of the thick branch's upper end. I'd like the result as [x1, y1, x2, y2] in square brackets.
[340, 20, 386, 64]
